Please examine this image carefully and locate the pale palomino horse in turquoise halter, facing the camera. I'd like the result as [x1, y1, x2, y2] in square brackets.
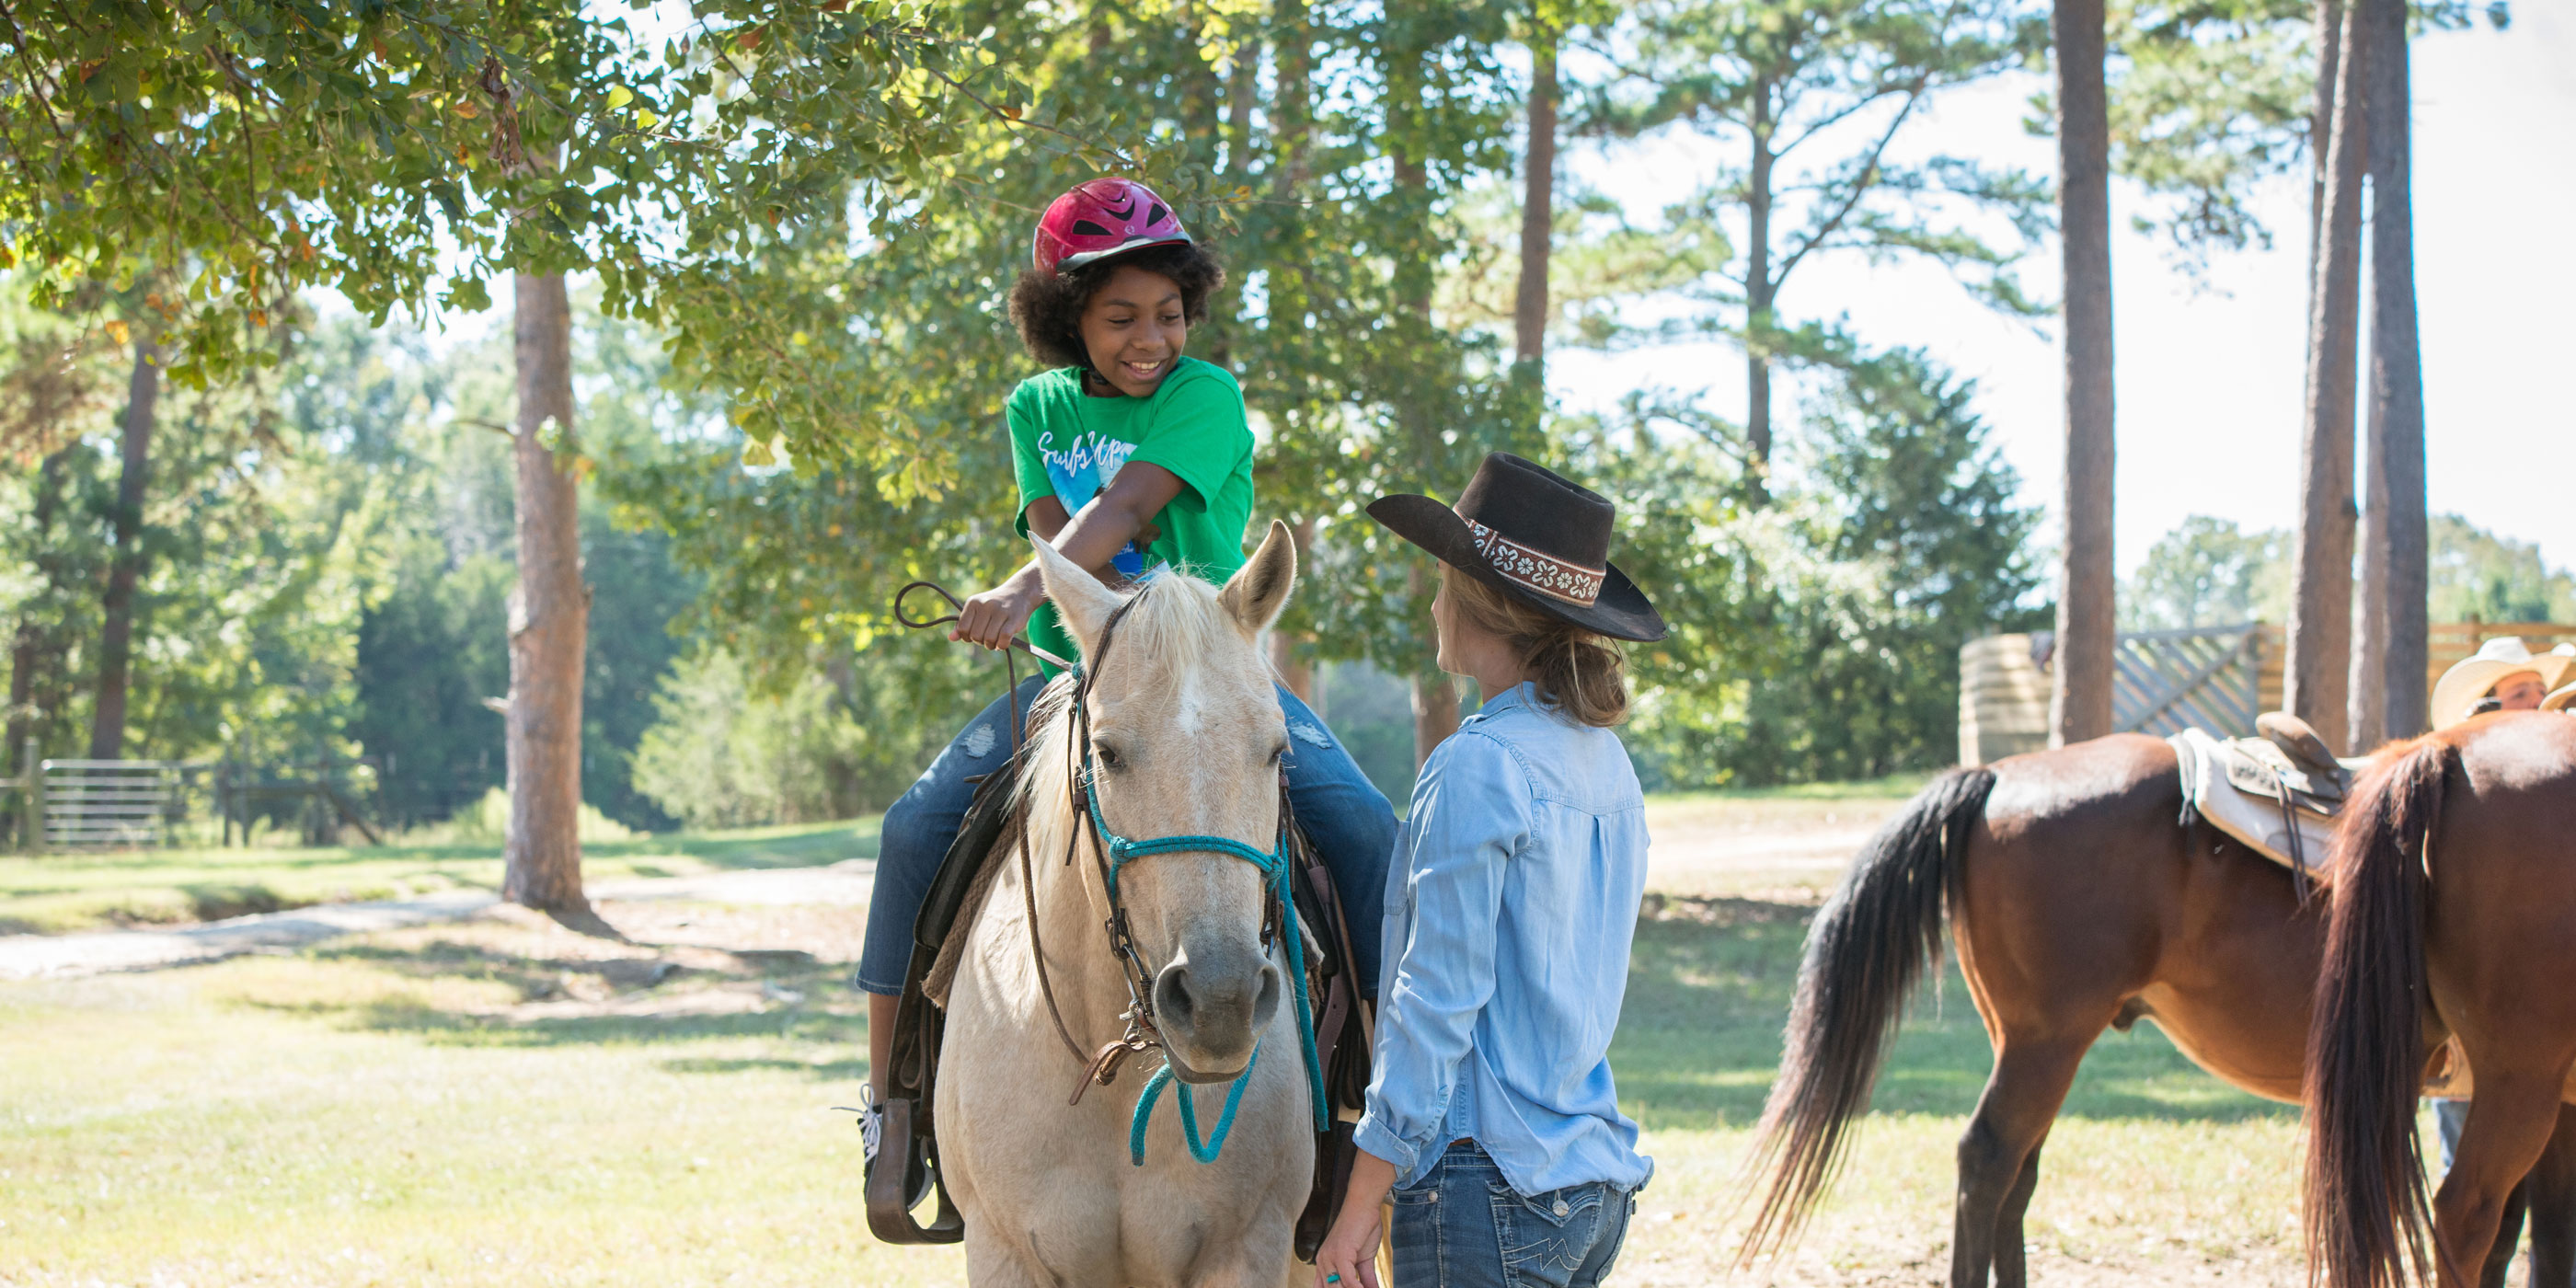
[935, 523, 1317, 1288]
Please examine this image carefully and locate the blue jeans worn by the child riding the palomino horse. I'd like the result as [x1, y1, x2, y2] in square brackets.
[857, 677, 1397, 997]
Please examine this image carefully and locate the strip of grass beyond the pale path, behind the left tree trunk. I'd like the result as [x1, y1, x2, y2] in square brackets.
[0, 817, 876, 935]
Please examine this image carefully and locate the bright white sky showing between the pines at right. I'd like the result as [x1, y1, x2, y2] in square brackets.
[1548, 3, 2576, 572]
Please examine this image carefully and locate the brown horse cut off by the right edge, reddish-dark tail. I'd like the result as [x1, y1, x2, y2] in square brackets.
[2308, 711, 2576, 1288]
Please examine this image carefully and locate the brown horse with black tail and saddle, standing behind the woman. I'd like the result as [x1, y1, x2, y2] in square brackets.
[1744, 721, 2576, 1288]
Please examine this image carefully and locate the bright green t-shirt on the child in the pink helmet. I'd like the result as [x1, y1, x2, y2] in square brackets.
[1007, 358, 1252, 657]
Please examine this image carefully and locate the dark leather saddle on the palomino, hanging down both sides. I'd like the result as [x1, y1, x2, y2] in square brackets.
[866, 706, 1368, 1262]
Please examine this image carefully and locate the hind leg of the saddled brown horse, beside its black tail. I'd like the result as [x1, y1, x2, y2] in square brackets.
[1950, 1028, 2102, 1288]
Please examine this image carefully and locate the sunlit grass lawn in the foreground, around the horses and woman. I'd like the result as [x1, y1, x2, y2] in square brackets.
[0, 791, 2359, 1285]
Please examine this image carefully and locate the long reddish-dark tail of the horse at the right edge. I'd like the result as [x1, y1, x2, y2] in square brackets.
[2308, 740, 2460, 1288]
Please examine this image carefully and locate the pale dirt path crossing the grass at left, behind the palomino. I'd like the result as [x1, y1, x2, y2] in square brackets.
[0, 857, 876, 979]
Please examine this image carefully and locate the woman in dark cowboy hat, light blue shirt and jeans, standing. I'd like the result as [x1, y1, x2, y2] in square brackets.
[1317, 454, 1664, 1288]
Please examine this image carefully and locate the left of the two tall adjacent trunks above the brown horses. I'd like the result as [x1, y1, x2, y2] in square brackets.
[2285, 10, 2367, 750]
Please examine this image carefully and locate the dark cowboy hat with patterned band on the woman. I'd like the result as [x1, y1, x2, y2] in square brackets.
[1368, 451, 1664, 641]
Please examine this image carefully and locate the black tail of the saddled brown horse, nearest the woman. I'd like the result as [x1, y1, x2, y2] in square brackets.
[1739, 767, 1994, 1265]
